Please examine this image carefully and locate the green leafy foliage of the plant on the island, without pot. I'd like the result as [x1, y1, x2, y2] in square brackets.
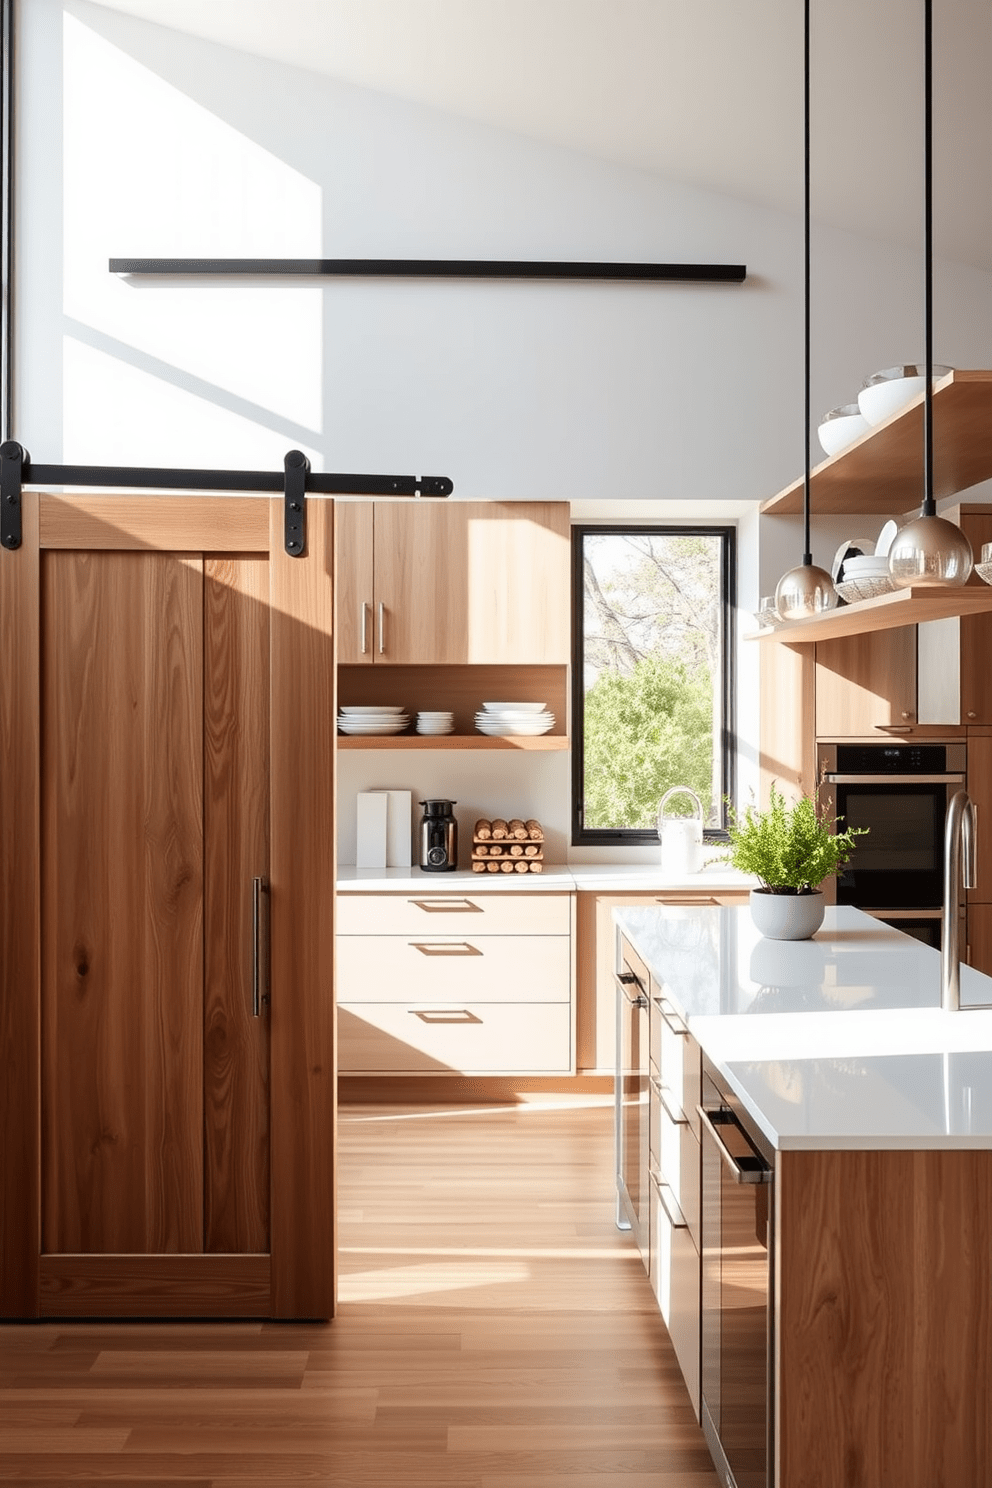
[726, 786, 869, 894]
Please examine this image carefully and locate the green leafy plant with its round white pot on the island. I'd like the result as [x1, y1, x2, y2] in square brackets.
[727, 786, 867, 940]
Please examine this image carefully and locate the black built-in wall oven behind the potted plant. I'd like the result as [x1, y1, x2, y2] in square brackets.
[817, 743, 967, 946]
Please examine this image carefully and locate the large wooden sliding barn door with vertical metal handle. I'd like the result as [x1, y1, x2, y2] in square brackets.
[0, 494, 335, 1317]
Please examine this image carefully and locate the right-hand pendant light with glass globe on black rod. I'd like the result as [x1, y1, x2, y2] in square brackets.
[889, 0, 974, 589]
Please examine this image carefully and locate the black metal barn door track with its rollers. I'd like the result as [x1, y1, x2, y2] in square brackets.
[0, 439, 455, 558]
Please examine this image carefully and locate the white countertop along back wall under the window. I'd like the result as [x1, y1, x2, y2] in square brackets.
[338, 863, 757, 894]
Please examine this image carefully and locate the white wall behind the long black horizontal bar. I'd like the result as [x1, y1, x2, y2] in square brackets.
[13, 0, 992, 862]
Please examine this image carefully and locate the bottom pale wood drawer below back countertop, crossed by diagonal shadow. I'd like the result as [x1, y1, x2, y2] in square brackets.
[338, 998, 573, 1074]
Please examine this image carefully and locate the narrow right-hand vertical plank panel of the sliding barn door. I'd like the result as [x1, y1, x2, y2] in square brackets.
[204, 555, 269, 1255]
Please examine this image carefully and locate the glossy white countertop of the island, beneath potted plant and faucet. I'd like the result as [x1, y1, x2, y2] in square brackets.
[614, 905, 992, 1149]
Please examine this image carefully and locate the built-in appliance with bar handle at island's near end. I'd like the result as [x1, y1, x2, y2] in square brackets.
[699, 1056, 775, 1488]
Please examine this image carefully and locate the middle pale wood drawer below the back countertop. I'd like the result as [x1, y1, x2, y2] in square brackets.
[336, 931, 571, 1003]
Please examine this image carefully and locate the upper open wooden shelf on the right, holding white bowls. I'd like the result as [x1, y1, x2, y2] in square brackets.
[761, 372, 992, 517]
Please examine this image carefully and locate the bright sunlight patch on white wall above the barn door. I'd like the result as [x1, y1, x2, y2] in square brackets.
[64, 15, 323, 466]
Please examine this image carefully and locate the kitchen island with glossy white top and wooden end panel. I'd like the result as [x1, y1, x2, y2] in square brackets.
[616, 906, 992, 1488]
